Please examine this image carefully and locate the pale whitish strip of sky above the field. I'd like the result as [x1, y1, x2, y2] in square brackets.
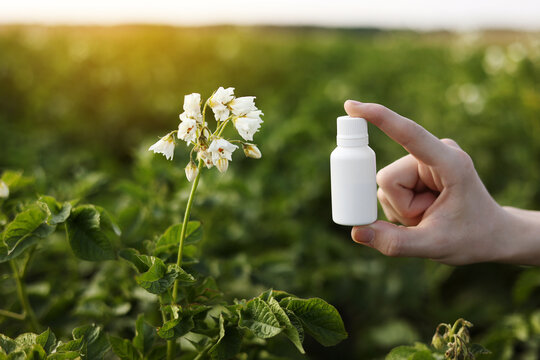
[0, 0, 540, 30]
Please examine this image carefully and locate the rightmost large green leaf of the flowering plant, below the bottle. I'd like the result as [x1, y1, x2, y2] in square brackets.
[280, 297, 347, 346]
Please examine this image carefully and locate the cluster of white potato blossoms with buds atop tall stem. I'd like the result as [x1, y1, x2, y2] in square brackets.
[148, 87, 264, 181]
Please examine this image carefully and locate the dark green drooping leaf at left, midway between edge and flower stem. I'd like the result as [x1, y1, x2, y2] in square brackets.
[66, 205, 115, 261]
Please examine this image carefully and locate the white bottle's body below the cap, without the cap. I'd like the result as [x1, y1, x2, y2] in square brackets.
[330, 144, 377, 226]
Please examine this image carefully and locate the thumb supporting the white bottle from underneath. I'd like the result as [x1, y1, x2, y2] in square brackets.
[351, 220, 432, 257]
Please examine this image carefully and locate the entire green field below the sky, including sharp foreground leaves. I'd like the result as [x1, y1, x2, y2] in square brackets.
[0, 26, 540, 359]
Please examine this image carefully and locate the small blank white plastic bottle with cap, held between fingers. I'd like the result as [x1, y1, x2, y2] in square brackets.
[330, 116, 377, 226]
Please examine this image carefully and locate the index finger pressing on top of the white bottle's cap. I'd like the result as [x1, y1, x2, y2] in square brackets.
[345, 100, 450, 166]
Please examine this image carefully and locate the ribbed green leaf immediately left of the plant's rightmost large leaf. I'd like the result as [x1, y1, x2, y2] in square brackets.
[238, 298, 282, 339]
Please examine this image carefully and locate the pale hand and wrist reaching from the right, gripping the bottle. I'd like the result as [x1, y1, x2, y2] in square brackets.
[345, 100, 540, 266]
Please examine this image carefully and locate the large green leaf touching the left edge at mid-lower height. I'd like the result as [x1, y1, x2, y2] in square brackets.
[0, 203, 56, 263]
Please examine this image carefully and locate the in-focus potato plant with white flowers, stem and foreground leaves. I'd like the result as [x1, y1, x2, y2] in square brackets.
[0, 88, 347, 360]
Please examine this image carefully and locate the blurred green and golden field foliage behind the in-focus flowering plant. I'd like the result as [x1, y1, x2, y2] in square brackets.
[0, 26, 540, 359]
